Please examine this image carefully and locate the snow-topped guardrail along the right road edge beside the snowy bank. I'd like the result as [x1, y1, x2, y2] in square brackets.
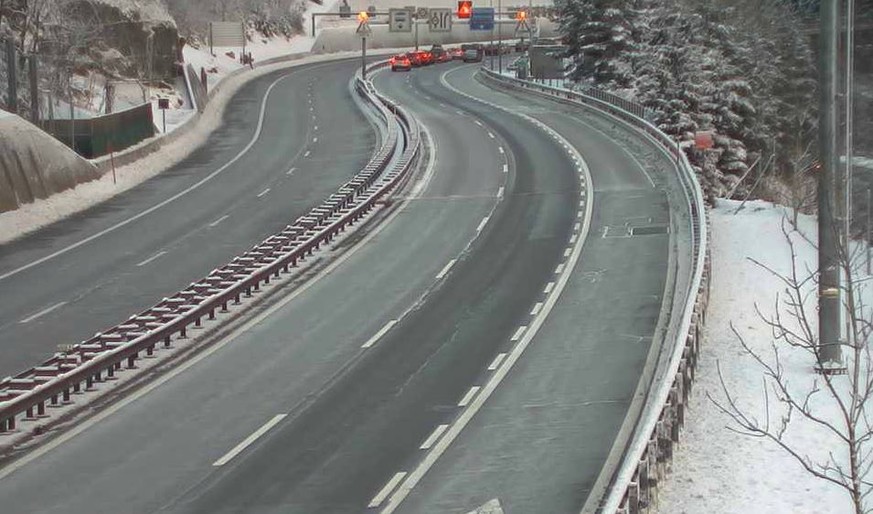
[482, 68, 710, 514]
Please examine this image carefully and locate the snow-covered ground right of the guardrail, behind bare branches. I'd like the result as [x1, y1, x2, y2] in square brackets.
[656, 201, 856, 514]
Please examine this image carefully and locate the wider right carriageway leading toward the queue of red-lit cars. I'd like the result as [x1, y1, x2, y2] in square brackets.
[0, 61, 670, 513]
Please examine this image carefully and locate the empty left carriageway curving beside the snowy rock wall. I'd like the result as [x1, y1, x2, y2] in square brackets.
[0, 59, 376, 377]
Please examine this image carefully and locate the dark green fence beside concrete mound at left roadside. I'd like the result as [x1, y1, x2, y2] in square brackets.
[43, 104, 155, 159]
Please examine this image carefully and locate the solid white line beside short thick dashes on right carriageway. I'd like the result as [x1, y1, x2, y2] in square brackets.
[381, 67, 593, 514]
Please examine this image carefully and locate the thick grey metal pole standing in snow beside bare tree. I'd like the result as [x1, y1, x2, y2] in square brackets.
[817, 0, 841, 367]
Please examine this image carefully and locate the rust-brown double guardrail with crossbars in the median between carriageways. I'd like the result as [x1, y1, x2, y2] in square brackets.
[0, 62, 420, 440]
